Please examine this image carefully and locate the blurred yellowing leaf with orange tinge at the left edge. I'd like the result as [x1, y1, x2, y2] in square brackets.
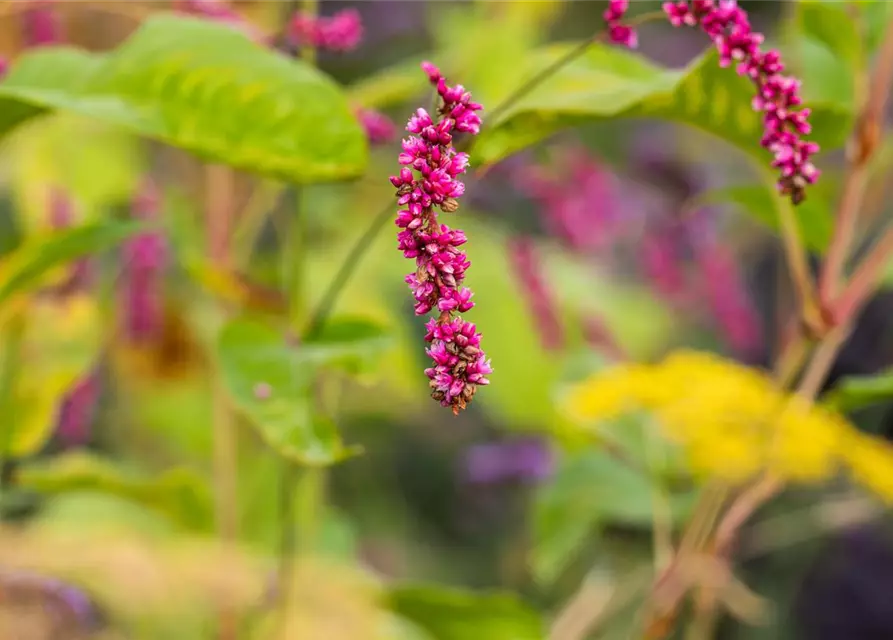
[4, 295, 103, 457]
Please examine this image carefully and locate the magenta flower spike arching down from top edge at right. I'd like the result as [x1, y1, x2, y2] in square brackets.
[605, 0, 819, 204]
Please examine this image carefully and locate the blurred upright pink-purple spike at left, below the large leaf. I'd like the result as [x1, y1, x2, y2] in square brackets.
[121, 181, 168, 343]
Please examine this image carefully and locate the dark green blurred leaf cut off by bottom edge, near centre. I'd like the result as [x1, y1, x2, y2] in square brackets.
[386, 586, 546, 640]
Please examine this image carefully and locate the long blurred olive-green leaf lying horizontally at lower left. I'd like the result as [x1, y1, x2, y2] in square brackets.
[18, 452, 213, 529]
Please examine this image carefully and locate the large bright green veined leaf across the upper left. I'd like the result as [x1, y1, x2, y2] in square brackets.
[0, 14, 368, 183]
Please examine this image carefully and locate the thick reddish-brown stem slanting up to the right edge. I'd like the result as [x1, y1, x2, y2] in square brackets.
[819, 14, 893, 305]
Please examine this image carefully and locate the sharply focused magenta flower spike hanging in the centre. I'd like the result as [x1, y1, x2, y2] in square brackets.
[391, 62, 493, 414]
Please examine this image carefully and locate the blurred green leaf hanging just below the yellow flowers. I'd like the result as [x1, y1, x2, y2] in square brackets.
[531, 451, 692, 584]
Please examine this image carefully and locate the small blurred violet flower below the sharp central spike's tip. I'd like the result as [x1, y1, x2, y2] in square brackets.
[464, 438, 555, 484]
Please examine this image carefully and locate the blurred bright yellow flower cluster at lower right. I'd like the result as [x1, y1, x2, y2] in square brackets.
[566, 351, 893, 499]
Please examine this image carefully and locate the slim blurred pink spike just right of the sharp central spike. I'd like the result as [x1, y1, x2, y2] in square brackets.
[507, 237, 564, 351]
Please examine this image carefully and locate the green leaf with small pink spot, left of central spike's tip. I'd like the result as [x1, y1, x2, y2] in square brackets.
[217, 318, 352, 465]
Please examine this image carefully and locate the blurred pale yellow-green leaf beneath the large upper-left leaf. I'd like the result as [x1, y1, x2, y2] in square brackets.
[7, 113, 143, 233]
